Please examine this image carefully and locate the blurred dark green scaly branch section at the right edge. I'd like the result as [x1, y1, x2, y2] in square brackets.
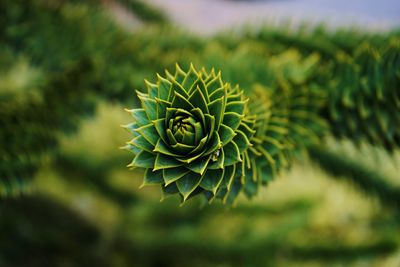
[324, 38, 400, 151]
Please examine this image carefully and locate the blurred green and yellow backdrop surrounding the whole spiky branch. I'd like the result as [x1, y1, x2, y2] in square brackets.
[0, 0, 400, 267]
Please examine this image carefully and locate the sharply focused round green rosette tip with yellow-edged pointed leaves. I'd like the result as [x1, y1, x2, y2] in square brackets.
[126, 65, 255, 201]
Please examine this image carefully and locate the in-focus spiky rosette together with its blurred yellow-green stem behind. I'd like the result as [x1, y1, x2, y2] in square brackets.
[125, 65, 324, 205]
